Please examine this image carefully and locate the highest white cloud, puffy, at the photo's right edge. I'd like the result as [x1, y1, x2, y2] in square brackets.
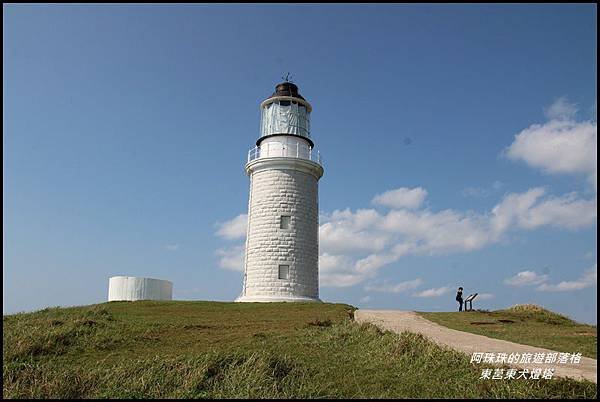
[505, 98, 597, 189]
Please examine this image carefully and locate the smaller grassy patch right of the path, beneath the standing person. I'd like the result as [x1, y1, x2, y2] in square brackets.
[419, 305, 596, 359]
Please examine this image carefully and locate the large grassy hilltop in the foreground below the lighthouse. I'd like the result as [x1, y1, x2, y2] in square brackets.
[2, 301, 597, 398]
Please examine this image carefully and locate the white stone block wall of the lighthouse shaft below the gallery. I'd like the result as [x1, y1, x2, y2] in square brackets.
[242, 168, 319, 299]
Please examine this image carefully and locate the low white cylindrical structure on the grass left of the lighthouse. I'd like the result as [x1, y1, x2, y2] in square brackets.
[108, 276, 173, 301]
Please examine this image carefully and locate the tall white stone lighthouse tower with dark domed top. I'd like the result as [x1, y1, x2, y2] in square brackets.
[236, 82, 323, 302]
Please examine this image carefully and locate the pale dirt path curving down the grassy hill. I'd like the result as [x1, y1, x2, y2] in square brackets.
[354, 310, 596, 382]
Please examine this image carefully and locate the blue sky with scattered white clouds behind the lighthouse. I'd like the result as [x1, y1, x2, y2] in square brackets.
[3, 4, 597, 323]
